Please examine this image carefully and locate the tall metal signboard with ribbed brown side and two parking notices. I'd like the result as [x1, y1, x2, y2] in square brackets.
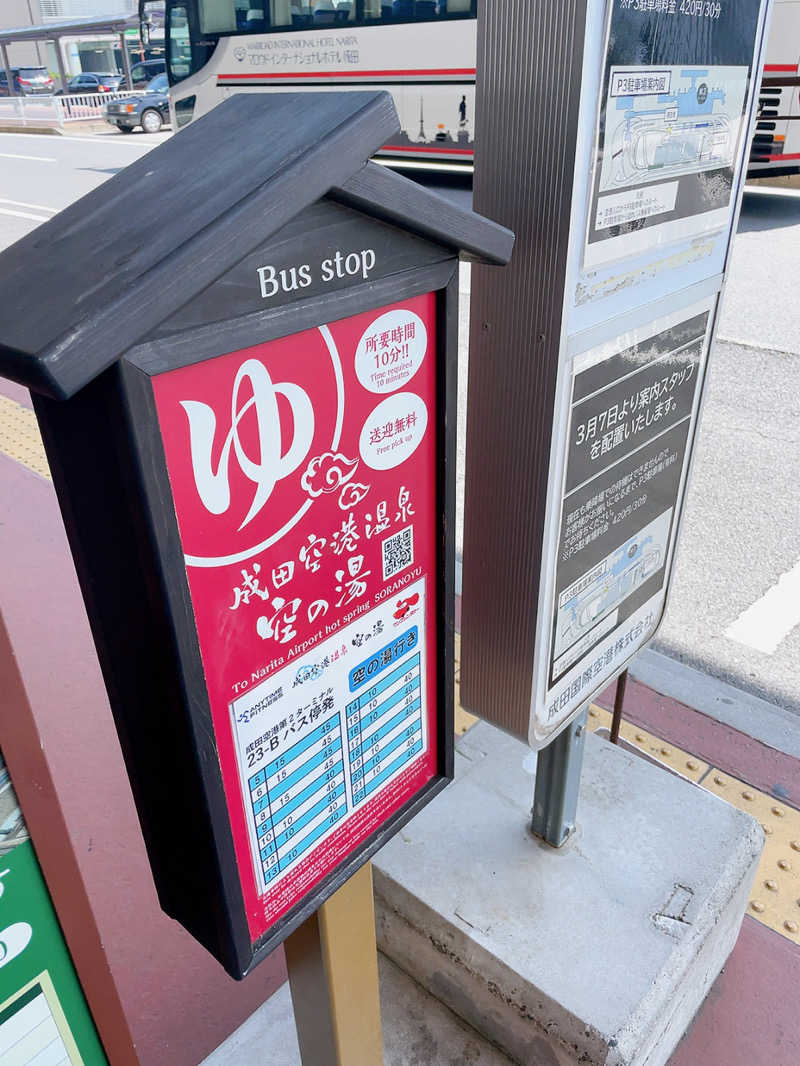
[461, 0, 768, 748]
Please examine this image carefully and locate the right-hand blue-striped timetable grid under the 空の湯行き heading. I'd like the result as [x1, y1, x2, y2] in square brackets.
[346, 630, 425, 807]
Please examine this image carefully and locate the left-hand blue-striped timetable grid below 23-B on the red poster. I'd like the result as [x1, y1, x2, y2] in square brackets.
[247, 712, 348, 885]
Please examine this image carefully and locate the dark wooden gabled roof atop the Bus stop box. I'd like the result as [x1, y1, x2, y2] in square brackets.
[0, 92, 513, 399]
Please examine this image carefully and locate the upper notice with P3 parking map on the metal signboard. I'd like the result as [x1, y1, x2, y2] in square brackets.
[583, 0, 758, 269]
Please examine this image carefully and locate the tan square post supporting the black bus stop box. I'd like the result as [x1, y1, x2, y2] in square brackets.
[284, 862, 383, 1066]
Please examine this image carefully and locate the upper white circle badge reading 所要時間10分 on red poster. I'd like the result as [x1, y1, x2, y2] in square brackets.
[355, 309, 428, 392]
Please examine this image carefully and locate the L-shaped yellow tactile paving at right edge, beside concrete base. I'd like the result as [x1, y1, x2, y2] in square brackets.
[702, 770, 800, 943]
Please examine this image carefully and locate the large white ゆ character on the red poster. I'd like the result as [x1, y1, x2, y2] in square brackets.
[180, 359, 314, 530]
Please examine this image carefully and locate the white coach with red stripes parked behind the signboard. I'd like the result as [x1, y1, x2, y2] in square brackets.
[140, 0, 800, 178]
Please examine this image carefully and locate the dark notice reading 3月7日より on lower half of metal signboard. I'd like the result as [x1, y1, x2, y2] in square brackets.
[543, 302, 713, 728]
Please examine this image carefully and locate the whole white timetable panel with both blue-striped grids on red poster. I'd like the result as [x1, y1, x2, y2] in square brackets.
[231, 605, 427, 893]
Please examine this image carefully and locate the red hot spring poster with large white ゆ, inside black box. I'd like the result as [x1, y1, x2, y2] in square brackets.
[153, 293, 436, 940]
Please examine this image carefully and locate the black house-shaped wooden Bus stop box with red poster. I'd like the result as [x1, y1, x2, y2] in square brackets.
[0, 93, 513, 978]
